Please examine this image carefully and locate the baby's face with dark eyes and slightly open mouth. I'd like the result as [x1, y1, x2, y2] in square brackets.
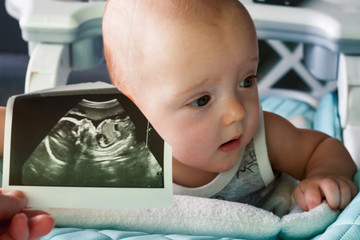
[120, 8, 259, 176]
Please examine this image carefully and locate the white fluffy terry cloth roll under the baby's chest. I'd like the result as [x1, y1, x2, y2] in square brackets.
[46, 172, 360, 239]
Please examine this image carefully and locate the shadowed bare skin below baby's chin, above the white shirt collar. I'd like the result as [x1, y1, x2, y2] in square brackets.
[172, 158, 218, 188]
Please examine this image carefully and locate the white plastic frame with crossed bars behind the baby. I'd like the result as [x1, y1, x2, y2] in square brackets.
[5, 0, 360, 167]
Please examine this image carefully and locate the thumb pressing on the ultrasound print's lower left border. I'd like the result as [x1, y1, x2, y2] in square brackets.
[0, 191, 27, 221]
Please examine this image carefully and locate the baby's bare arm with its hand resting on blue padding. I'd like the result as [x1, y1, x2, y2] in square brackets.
[265, 113, 357, 210]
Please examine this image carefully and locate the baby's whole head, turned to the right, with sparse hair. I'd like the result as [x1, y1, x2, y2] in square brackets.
[103, 0, 259, 178]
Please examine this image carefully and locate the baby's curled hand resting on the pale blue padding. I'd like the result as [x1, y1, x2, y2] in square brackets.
[294, 174, 358, 210]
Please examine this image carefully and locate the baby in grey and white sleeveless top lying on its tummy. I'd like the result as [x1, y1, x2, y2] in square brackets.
[0, 0, 358, 238]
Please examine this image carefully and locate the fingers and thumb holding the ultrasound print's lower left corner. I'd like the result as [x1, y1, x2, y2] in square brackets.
[0, 189, 55, 240]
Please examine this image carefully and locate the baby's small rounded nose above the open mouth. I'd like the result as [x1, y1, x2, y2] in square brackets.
[222, 99, 246, 126]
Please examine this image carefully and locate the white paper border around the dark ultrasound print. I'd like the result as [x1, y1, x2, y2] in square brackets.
[2, 87, 173, 209]
